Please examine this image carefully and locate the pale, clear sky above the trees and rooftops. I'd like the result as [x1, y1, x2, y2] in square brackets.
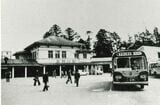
[1, 0, 160, 53]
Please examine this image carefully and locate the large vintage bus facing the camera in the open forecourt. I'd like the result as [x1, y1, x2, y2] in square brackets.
[112, 50, 148, 89]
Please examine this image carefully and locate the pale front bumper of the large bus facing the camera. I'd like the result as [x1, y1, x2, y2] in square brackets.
[113, 81, 148, 85]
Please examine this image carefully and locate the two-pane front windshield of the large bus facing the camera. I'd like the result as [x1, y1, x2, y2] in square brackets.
[117, 57, 145, 70]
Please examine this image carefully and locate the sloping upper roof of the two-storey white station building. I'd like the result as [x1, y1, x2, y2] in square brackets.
[24, 36, 83, 50]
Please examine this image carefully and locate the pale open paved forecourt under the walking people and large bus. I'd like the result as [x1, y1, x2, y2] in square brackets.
[1, 74, 160, 105]
